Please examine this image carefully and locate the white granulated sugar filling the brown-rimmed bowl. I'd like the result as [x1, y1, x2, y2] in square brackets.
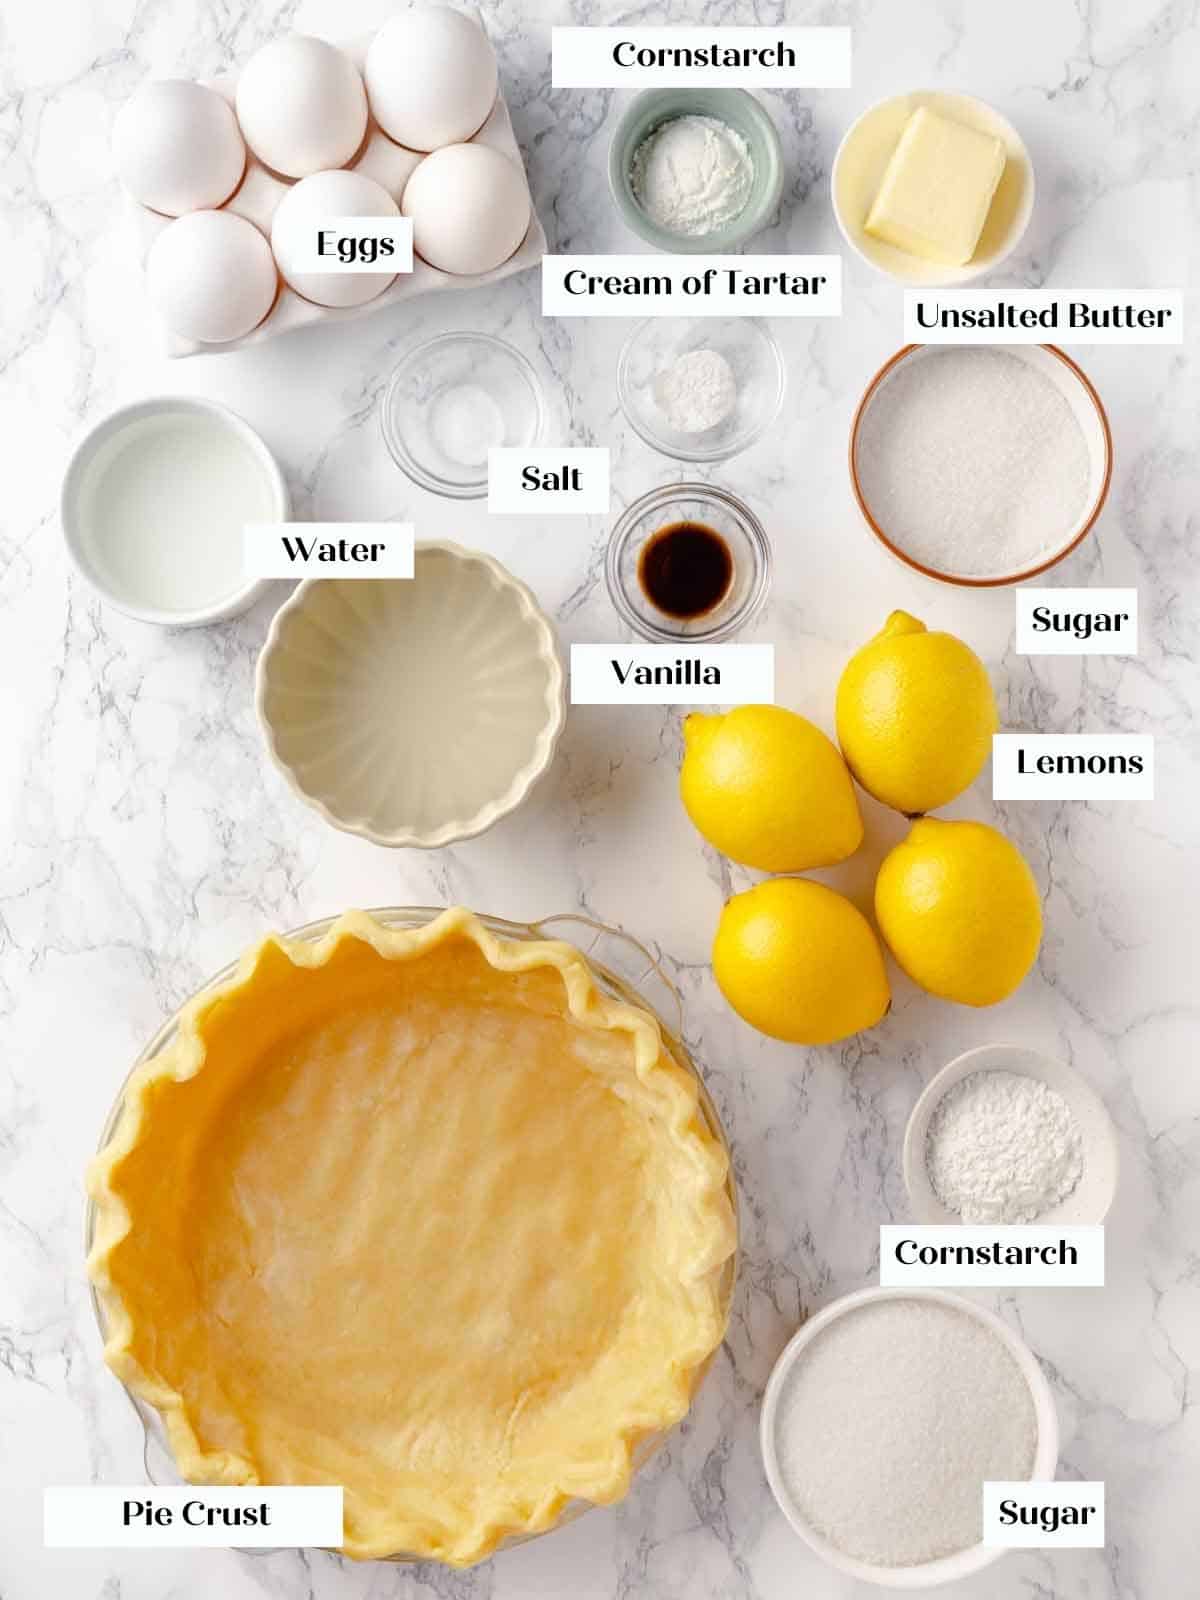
[856, 346, 1091, 578]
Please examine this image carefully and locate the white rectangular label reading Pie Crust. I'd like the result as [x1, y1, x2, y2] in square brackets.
[42, 1483, 342, 1550]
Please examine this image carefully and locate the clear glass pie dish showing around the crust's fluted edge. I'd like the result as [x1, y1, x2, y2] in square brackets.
[86, 907, 736, 1562]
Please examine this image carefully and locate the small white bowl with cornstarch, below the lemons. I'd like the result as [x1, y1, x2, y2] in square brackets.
[904, 1045, 1118, 1227]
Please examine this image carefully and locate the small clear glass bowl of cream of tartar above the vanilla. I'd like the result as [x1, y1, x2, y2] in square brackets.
[616, 317, 787, 461]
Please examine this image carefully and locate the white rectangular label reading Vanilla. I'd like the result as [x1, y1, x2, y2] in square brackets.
[571, 642, 774, 706]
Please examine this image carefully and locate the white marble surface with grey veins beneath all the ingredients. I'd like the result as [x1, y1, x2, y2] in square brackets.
[0, 0, 1200, 1600]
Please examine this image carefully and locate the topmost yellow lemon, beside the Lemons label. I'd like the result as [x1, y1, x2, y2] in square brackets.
[837, 611, 1000, 816]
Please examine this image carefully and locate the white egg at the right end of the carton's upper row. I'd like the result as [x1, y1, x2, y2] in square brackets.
[363, 5, 498, 150]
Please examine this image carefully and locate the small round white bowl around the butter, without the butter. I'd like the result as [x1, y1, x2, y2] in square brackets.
[830, 90, 1034, 288]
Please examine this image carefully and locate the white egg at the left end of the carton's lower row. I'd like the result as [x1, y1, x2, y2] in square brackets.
[146, 211, 278, 344]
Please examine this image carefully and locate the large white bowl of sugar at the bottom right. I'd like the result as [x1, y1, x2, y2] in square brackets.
[762, 1288, 1058, 1589]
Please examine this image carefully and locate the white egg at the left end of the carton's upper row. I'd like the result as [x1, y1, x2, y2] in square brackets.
[112, 78, 246, 216]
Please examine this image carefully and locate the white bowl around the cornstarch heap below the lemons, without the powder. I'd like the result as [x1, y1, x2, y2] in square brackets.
[904, 1045, 1118, 1227]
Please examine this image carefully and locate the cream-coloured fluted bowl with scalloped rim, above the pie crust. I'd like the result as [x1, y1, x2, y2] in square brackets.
[256, 542, 566, 848]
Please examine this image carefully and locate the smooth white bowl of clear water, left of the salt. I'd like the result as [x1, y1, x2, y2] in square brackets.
[61, 395, 290, 627]
